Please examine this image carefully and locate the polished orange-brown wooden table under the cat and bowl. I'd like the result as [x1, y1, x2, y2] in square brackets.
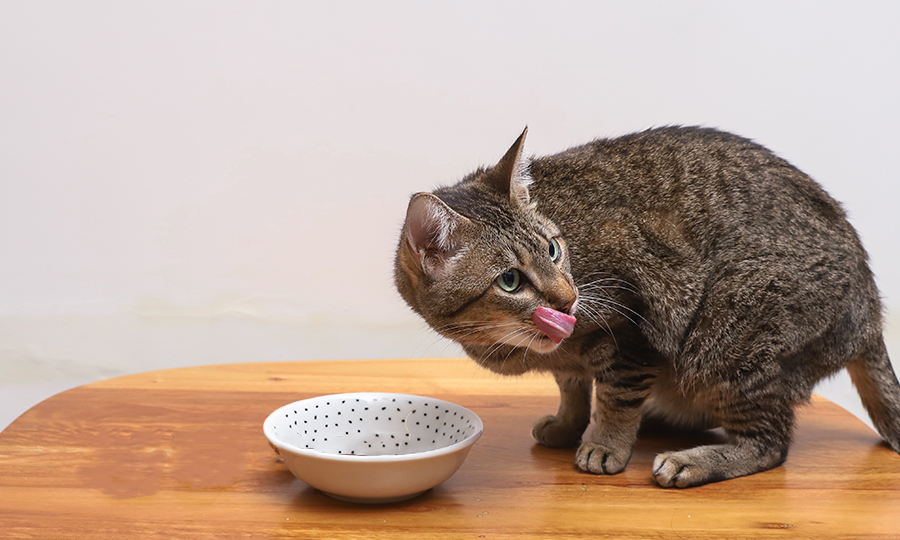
[0, 359, 900, 540]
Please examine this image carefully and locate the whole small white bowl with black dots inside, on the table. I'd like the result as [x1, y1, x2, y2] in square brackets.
[263, 392, 484, 503]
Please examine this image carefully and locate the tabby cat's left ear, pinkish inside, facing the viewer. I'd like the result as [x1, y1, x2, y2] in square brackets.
[405, 193, 469, 279]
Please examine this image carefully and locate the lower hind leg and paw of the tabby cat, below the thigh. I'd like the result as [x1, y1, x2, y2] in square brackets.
[653, 384, 794, 488]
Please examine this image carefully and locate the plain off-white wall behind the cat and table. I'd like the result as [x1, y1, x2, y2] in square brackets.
[0, 0, 900, 427]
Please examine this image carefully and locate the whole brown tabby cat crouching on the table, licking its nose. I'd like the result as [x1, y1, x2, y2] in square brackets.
[394, 126, 900, 487]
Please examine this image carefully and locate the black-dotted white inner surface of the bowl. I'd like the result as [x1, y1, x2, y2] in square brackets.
[272, 393, 482, 456]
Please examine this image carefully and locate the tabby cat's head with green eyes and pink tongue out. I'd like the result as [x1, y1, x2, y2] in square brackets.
[395, 130, 578, 360]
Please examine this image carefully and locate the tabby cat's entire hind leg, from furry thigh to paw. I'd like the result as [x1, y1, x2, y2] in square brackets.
[653, 258, 824, 487]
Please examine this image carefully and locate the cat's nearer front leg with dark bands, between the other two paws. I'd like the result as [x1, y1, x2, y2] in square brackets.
[575, 370, 654, 474]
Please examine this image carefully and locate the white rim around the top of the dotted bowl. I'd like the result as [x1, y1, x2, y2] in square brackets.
[263, 392, 484, 463]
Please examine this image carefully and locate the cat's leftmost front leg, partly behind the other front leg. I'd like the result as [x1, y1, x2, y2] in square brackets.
[531, 373, 592, 447]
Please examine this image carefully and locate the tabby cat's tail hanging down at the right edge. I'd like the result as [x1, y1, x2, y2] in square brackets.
[847, 336, 900, 453]
